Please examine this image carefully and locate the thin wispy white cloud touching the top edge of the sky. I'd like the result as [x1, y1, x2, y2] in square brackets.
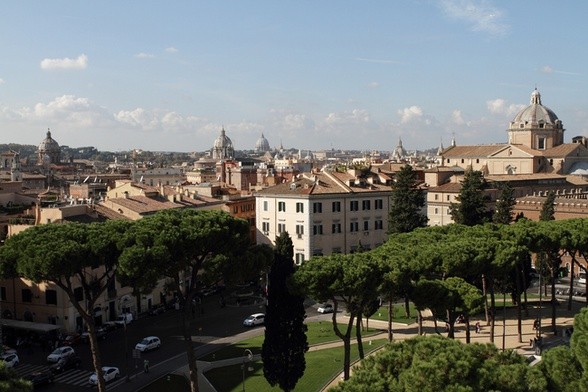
[438, 0, 510, 36]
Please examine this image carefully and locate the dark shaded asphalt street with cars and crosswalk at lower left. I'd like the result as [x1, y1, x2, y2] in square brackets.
[10, 294, 274, 392]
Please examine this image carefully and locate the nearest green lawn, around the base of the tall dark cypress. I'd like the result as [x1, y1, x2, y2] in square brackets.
[205, 339, 387, 392]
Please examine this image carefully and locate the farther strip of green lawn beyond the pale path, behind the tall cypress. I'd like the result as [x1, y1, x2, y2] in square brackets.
[198, 321, 380, 362]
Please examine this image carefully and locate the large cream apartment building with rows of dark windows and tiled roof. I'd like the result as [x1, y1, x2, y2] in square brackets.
[255, 170, 391, 264]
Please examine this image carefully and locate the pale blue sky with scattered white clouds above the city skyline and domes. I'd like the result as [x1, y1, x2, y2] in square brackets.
[0, 0, 588, 152]
